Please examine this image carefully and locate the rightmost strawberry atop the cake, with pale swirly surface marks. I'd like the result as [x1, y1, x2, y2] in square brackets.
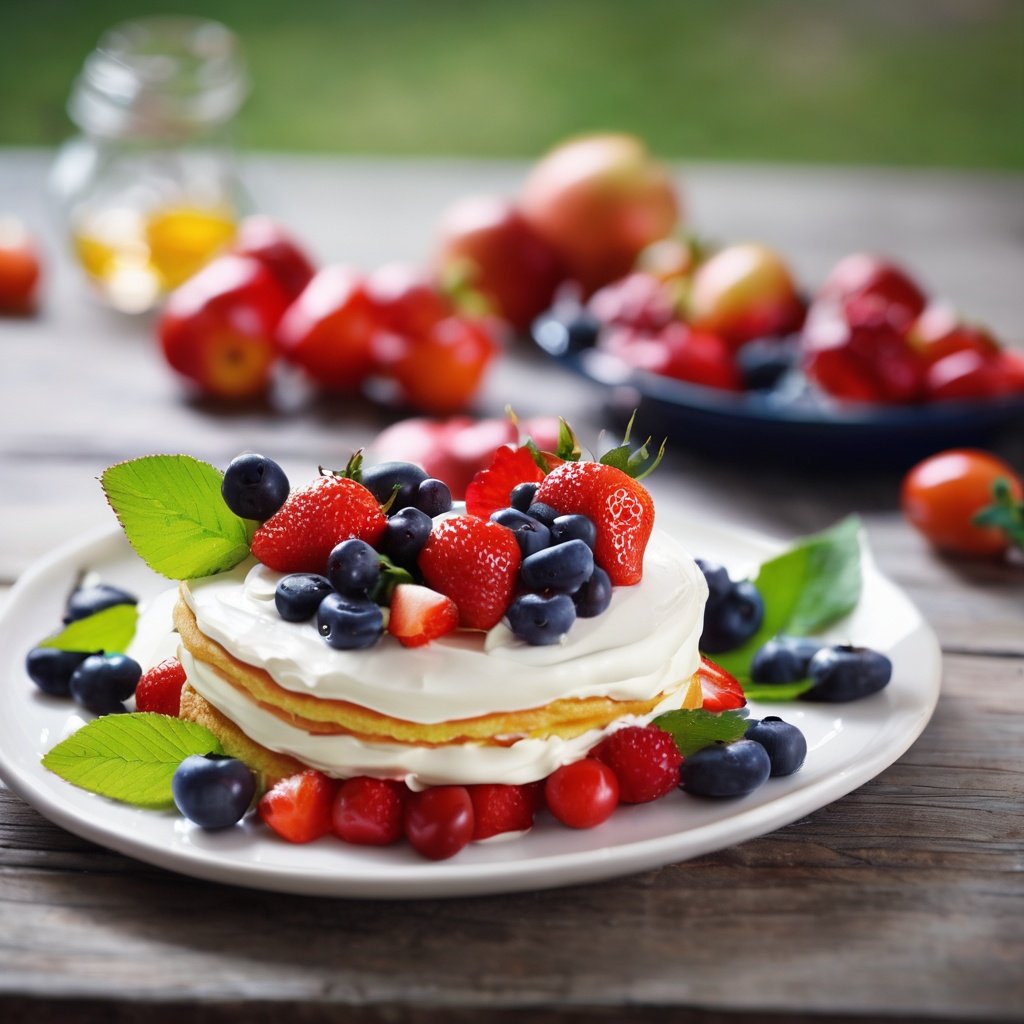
[536, 462, 654, 587]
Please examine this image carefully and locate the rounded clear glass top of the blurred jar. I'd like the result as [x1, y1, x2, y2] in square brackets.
[68, 17, 249, 138]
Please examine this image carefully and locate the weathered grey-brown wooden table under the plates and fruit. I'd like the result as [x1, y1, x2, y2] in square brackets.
[0, 151, 1024, 1024]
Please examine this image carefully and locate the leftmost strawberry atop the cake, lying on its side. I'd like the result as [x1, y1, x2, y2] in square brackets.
[252, 473, 387, 573]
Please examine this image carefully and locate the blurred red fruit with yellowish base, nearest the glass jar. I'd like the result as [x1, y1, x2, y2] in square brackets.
[157, 256, 288, 398]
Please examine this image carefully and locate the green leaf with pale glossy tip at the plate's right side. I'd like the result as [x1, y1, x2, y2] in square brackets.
[714, 516, 861, 689]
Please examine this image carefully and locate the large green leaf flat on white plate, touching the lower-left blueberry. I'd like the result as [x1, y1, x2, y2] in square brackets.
[42, 712, 223, 808]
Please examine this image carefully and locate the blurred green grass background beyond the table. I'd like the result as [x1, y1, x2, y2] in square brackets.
[0, 0, 1024, 170]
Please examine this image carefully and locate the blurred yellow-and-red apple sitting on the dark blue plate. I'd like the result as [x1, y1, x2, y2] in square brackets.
[689, 243, 804, 348]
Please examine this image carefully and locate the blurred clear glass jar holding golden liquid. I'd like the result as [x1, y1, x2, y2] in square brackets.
[51, 17, 249, 312]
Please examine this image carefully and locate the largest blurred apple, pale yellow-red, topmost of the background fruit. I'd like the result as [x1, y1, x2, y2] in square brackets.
[519, 134, 680, 294]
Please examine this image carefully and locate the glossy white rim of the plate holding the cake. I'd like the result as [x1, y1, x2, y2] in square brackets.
[0, 520, 941, 899]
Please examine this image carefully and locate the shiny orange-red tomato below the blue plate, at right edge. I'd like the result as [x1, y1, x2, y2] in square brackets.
[900, 449, 1024, 556]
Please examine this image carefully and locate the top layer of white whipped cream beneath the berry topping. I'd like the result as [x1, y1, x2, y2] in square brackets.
[183, 532, 708, 724]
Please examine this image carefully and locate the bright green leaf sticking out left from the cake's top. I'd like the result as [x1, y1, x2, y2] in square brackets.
[100, 455, 256, 580]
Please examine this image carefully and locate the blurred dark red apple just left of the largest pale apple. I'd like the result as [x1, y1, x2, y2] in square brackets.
[433, 196, 562, 331]
